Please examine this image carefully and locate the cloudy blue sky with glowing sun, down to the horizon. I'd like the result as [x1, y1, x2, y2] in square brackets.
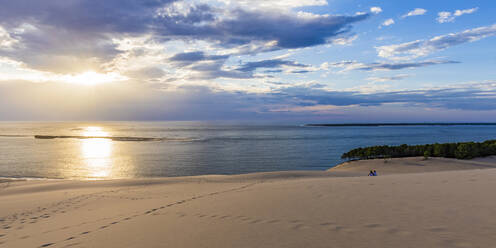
[0, 0, 496, 123]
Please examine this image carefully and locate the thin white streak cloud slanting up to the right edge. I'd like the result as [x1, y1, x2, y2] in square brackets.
[376, 24, 496, 59]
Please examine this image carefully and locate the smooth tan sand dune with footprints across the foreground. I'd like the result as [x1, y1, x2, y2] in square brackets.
[0, 157, 496, 248]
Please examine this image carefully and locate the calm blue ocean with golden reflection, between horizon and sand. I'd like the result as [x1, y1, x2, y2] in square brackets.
[0, 122, 496, 179]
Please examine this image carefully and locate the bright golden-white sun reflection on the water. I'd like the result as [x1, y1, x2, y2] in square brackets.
[81, 127, 112, 178]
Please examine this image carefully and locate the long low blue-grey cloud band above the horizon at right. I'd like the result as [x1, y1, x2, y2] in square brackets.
[278, 81, 496, 111]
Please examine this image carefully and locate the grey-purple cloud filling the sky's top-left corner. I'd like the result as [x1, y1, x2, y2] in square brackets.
[0, 0, 175, 34]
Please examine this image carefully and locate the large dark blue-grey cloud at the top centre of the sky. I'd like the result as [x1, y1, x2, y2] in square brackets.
[191, 10, 369, 49]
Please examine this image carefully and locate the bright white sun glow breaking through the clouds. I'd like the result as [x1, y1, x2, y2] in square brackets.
[62, 71, 127, 85]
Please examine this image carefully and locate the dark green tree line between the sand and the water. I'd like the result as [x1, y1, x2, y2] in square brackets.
[341, 140, 496, 160]
